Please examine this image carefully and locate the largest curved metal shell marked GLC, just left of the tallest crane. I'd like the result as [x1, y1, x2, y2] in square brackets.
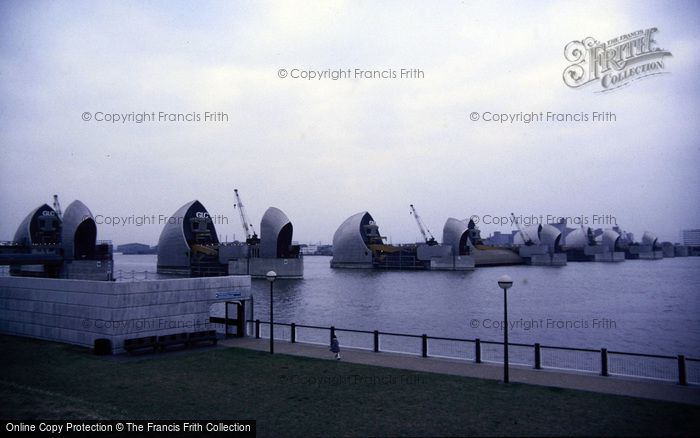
[158, 200, 219, 267]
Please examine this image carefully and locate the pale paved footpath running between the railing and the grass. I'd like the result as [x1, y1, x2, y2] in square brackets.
[219, 338, 700, 405]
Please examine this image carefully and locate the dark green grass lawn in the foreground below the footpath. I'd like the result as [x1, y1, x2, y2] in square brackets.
[0, 336, 700, 436]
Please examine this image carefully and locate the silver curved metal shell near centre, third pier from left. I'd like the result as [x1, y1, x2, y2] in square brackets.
[332, 211, 375, 263]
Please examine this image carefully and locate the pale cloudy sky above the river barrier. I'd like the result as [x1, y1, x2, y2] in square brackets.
[0, 0, 700, 244]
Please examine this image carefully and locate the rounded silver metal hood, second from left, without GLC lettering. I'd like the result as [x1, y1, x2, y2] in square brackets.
[61, 200, 97, 260]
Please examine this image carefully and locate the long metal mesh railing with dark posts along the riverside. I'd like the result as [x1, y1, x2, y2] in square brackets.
[247, 319, 700, 385]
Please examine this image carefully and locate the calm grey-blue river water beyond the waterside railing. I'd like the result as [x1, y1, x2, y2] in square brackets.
[114, 254, 700, 357]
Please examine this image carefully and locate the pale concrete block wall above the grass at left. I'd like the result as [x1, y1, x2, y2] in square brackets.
[0, 276, 252, 353]
